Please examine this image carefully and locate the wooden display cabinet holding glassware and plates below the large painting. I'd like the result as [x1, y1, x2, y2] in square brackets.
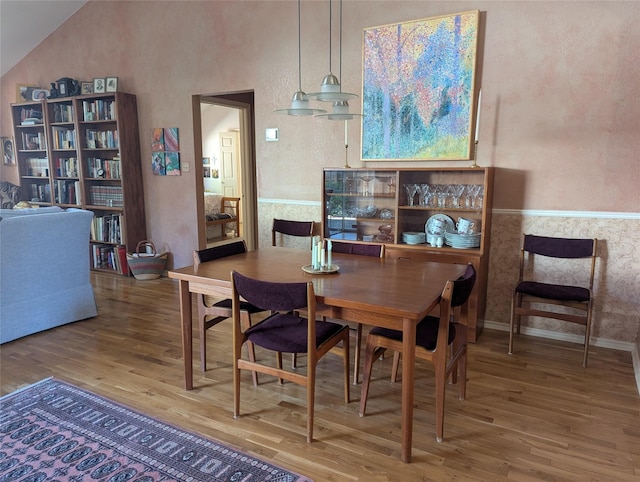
[322, 167, 494, 342]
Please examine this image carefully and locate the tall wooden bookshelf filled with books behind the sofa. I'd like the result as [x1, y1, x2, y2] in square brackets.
[11, 92, 147, 275]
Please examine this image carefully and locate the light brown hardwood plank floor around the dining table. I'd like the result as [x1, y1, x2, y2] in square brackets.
[0, 273, 640, 482]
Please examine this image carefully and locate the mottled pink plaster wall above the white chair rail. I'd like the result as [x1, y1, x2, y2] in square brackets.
[0, 1, 640, 266]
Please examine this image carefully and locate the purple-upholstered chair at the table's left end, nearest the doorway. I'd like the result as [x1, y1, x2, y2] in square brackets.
[193, 240, 262, 385]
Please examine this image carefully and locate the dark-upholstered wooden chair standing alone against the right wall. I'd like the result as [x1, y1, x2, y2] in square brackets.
[509, 234, 598, 368]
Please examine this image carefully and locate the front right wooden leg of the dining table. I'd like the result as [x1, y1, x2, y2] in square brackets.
[400, 318, 416, 464]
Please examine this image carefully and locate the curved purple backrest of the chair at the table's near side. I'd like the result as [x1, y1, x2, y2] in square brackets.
[232, 271, 309, 311]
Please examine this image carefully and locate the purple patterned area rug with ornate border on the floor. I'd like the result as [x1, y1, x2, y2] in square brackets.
[0, 379, 312, 482]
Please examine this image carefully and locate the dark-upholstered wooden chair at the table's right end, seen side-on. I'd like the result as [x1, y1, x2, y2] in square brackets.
[360, 264, 476, 442]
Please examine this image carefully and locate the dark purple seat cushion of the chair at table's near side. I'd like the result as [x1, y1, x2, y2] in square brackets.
[246, 313, 345, 353]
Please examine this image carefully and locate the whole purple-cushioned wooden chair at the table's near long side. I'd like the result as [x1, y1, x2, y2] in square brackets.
[231, 271, 350, 442]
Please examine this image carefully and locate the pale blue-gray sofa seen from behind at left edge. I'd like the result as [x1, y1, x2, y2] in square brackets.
[0, 207, 98, 343]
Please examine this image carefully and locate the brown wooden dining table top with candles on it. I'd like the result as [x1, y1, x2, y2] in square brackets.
[169, 247, 466, 320]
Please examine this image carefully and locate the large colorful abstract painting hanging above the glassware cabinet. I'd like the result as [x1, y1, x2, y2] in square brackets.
[362, 10, 479, 161]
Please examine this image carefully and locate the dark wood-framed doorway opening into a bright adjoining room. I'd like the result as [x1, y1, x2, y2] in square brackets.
[192, 91, 258, 250]
